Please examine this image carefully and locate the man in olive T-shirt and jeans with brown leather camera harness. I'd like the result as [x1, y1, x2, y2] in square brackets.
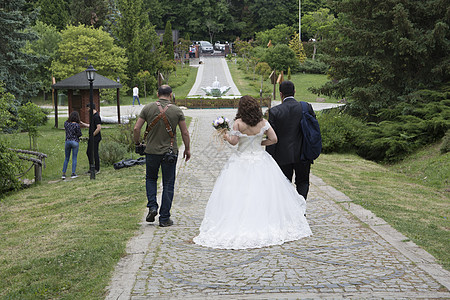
[134, 85, 191, 227]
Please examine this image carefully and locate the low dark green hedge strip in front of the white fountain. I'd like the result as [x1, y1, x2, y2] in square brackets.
[175, 97, 272, 108]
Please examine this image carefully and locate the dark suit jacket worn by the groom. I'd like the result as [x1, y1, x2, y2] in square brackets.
[266, 97, 315, 166]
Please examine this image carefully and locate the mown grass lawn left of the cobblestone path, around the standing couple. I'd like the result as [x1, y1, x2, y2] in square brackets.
[0, 117, 191, 299]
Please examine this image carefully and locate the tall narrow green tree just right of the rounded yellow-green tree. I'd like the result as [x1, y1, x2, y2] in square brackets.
[115, 0, 162, 85]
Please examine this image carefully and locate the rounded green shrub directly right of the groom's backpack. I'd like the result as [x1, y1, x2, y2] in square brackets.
[317, 109, 364, 153]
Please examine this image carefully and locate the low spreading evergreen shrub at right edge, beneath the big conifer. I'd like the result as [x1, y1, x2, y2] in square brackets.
[357, 96, 450, 162]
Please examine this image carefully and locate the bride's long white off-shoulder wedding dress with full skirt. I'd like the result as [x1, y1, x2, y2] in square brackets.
[194, 121, 312, 249]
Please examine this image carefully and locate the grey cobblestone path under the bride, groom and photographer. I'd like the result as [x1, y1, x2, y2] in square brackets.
[109, 109, 450, 300]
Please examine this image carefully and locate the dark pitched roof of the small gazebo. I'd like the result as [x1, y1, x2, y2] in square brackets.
[52, 71, 122, 90]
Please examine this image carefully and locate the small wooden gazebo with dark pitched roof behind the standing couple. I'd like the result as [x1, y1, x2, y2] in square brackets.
[52, 71, 122, 128]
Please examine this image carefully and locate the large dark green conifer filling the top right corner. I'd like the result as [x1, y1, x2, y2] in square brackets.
[319, 0, 450, 117]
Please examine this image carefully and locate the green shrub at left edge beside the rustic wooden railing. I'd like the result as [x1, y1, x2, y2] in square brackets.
[0, 139, 22, 195]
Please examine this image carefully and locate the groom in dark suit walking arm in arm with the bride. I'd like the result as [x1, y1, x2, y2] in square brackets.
[266, 81, 315, 200]
